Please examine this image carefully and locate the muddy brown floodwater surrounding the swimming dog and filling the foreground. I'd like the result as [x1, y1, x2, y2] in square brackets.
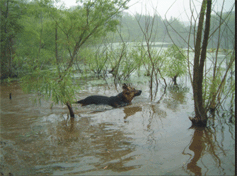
[0, 83, 235, 175]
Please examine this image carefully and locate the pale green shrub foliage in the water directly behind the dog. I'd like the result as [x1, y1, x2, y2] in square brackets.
[80, 43, 141, 79]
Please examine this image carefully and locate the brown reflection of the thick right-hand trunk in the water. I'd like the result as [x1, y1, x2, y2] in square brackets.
[183, 123, 235, 175]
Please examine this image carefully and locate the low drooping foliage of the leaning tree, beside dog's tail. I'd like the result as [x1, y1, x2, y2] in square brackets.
[21, 68, 78, 104]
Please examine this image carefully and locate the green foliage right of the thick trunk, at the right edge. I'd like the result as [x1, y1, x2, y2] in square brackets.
[203, 52, 235, 109]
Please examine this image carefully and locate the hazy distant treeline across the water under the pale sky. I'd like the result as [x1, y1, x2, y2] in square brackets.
[109, 11, 235, 49]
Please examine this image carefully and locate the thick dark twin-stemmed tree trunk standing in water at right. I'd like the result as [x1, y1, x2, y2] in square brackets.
[190, 0, 212, 126]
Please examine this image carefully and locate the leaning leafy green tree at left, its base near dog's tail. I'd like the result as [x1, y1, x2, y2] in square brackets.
[19, 0, 128, 117]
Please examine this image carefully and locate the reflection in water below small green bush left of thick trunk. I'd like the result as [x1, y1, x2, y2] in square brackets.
[163, 85, 189, 110]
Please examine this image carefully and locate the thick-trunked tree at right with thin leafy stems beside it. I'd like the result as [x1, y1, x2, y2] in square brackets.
[190, 0, 235, 126]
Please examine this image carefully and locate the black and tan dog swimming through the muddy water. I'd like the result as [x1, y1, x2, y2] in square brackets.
[76, 84, 142, 108]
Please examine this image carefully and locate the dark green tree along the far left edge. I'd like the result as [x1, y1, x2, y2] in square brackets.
[0, 0, 23, 79]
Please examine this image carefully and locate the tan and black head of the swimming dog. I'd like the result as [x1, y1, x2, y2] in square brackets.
[123, 84, 142, 103]
